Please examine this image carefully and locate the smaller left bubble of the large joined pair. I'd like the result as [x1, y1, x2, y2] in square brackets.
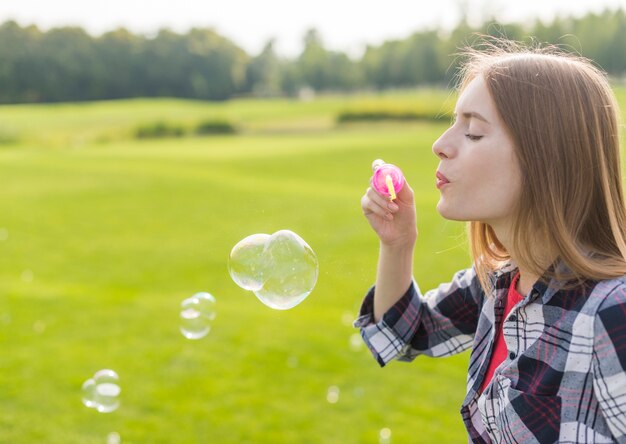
[228, 233, 270, 291]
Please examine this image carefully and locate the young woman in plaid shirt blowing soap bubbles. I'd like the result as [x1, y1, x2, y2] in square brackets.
[355, 42, 626, 443]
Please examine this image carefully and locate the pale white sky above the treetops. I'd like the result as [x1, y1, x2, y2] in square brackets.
[0, 0, 626, 57]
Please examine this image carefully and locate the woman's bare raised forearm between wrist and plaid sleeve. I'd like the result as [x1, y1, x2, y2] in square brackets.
[374, 242, 414, 322]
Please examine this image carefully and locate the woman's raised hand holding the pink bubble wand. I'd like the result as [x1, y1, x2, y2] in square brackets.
[361, 160, 417, 247]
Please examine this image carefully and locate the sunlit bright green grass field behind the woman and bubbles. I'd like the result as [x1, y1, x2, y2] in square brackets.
[0, 87, 623, 444]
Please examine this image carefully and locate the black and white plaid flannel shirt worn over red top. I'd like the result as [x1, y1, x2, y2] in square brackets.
[355, 264, 626, 443]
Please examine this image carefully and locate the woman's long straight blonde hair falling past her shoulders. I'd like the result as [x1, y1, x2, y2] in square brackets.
[460, 41, 626, 290]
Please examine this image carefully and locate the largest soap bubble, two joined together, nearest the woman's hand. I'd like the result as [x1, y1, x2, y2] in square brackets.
[228, 230, 318, 310]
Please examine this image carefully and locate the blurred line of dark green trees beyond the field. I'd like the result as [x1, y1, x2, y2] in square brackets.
[0, 9, 626, 103]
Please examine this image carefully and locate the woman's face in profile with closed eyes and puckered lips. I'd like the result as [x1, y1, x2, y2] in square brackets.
[433, 77, 521, 229]
